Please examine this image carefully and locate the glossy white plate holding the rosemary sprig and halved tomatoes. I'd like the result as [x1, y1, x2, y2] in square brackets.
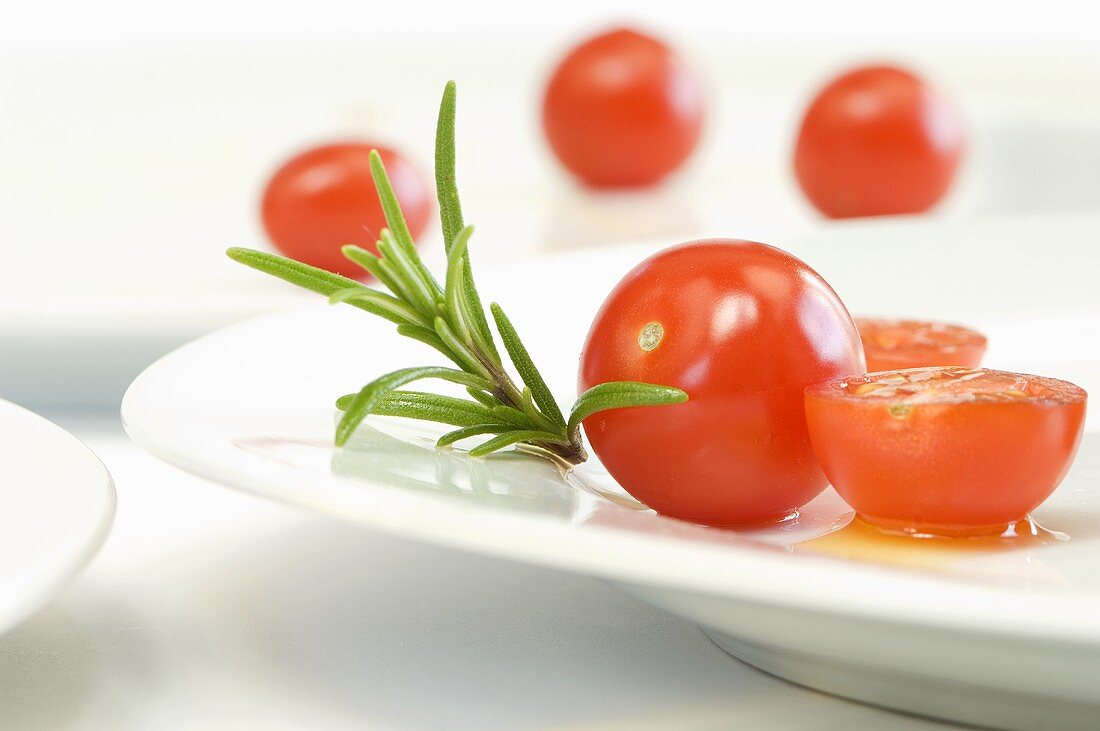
[123, 222, 1100, 729]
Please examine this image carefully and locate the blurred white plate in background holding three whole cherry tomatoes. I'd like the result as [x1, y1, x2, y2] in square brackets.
[0, 41, 1100, 406]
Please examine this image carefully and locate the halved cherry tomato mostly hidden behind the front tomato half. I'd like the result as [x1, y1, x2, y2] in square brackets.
[856, 318, 986, 373]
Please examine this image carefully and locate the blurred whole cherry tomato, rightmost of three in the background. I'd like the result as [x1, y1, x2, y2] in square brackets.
[794, 66, 964, 219]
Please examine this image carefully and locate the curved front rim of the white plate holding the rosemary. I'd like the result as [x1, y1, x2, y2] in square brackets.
[121, 306, 1100, 649]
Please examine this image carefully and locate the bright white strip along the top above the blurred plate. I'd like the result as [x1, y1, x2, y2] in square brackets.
[0, 0, 1098, 48]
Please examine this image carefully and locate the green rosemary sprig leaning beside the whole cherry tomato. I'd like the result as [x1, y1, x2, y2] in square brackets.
[227, 81, 688, 464]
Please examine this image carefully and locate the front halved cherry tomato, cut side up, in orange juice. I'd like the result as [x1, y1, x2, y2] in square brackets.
[806, 367, 1087, 535]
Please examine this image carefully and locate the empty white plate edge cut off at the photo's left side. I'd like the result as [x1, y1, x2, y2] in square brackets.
[0, 400, 114, 632]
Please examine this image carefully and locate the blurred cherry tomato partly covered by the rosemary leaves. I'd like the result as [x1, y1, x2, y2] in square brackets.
[261, 142, 432, 277]
